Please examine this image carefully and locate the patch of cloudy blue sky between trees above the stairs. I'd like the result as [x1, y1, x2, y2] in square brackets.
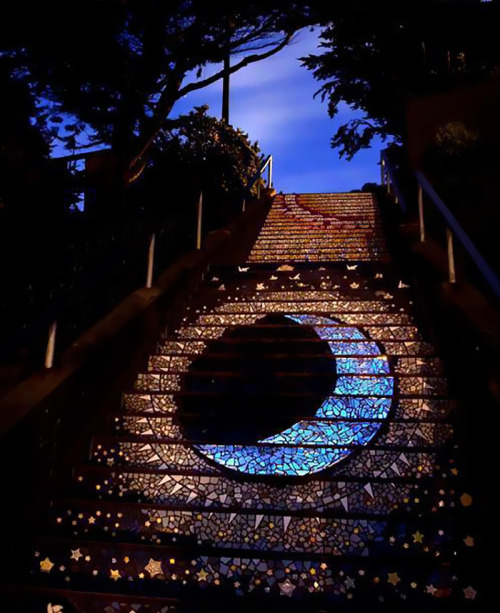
[173, 30, 381, 193]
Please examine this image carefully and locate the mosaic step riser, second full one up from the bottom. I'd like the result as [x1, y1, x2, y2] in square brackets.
[47, 494, 458, 555]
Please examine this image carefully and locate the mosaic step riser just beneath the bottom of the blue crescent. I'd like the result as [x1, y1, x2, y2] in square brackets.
[68, 460, 460, 506]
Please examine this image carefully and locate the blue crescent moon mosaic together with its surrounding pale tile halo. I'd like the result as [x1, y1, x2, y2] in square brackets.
[122, 273, 449, 568]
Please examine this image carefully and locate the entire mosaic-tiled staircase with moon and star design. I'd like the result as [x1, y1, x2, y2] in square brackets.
[15, 194, 480, 613]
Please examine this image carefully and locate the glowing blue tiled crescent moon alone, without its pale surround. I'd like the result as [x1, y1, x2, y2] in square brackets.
[196, 315, 394, 476]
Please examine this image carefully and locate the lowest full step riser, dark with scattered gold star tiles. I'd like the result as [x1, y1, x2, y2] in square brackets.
[32, 524, 463, 611]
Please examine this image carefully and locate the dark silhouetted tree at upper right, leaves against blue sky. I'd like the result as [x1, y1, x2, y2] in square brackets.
[302, 0, 500, 159]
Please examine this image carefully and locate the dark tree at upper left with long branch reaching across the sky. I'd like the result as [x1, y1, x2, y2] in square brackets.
[0, 0, 312, 181]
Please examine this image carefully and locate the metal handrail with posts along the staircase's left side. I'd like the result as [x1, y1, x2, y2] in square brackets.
[0, 156, 273, 376]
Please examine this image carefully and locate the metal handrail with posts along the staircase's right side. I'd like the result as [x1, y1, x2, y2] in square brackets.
[380, 151, 500, 301]
